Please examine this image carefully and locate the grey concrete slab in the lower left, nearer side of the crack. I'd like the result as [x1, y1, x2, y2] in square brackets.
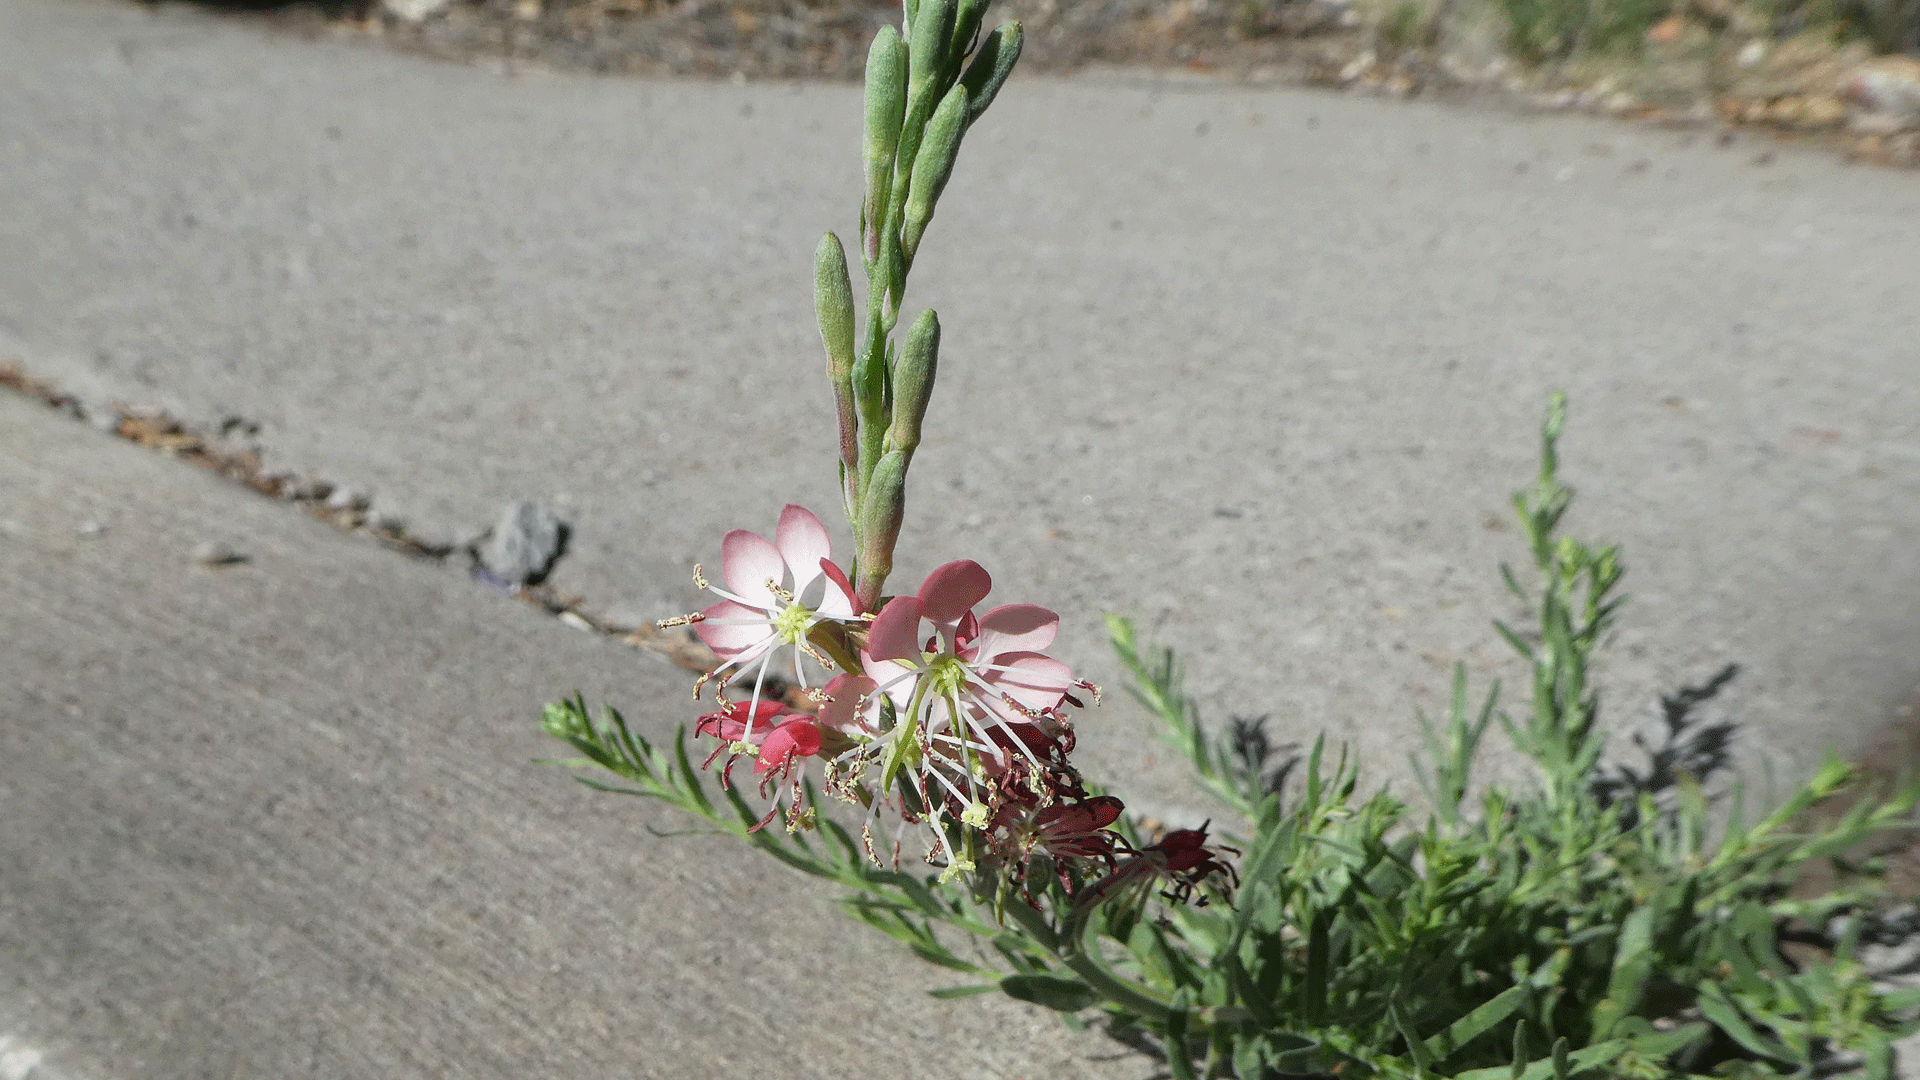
[0, 394, 1150, 1080]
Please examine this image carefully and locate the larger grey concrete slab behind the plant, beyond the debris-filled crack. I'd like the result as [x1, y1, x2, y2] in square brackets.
[0, 0, 1920, 815]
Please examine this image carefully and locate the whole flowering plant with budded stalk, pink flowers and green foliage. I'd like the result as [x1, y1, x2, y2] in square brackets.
[545, 0, 1920, 1080]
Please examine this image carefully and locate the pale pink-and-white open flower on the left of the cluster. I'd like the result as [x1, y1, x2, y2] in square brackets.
[662, 503, 860, 742]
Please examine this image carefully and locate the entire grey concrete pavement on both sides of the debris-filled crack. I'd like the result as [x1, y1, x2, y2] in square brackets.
[0, 0, 1920, 1078]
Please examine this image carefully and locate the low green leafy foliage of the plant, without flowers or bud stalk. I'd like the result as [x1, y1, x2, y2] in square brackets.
[545, 400, 1920, 1080]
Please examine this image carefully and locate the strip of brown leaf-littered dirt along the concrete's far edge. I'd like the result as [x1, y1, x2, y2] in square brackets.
[183, 0, 1920, 167]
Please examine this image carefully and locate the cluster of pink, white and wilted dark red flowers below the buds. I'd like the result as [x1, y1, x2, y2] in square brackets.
[662, 505, 1217, 892]
